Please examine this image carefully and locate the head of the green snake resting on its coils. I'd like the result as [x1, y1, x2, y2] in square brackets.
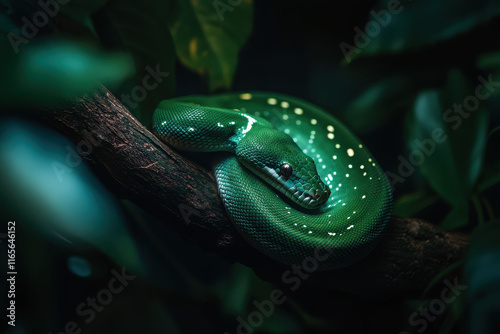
[236, 128, 330, 209]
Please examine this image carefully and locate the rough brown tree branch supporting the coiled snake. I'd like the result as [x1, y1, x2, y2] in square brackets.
[44, 88, 468, 297]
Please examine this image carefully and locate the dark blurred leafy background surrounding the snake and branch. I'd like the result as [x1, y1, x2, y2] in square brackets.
[0, 0, 500, 333]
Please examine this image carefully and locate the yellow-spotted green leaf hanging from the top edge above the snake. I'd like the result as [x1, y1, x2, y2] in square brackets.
[170, 0, 253, 91]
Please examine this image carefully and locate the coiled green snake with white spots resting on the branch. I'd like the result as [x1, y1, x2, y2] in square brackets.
[153, 93, 392, 270]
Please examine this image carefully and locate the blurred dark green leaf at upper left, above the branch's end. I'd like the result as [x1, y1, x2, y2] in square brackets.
[0, 39, 132, 107]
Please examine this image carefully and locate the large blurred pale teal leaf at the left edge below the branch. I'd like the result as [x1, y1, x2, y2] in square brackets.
[0, 120, 142, 271]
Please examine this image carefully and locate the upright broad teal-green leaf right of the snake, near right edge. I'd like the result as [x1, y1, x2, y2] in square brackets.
[408, 71, 488, 228]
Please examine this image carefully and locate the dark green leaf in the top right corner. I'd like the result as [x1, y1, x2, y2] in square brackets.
[358, 0, 500, 55]
